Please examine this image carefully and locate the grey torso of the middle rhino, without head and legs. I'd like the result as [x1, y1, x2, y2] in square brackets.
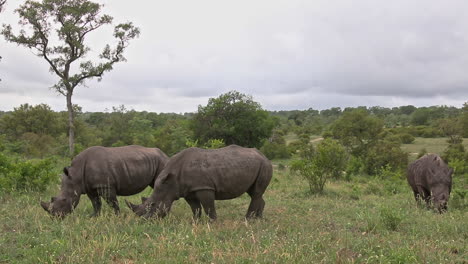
[162, 145, 272, 200]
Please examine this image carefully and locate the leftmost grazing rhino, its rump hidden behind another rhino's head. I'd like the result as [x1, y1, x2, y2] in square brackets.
[41, 146, 169, 217]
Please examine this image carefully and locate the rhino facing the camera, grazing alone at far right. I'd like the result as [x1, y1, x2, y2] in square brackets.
[407, 154, 453, 213]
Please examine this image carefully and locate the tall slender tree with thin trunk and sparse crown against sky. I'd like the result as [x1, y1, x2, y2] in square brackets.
[2, 0, 140, 155]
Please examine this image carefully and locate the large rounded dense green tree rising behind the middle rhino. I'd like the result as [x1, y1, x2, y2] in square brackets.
[191, 91, 276, 148]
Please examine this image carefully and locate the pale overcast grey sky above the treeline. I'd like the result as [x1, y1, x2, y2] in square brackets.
[0, 0, 468, 113]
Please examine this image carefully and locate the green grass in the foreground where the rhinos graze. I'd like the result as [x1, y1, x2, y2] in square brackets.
[0, 163, 468, 263]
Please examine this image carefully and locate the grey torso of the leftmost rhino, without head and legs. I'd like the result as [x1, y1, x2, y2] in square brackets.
[69, 146, 167, 195]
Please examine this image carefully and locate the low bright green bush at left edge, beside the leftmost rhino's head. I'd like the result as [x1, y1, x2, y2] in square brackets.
[0, 153, 57, 192]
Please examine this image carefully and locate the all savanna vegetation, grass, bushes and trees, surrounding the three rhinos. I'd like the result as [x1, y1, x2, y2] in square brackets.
[0, 0, 468, 263]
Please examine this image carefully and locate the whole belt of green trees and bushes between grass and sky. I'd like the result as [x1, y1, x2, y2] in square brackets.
[0, 91, 468, 195]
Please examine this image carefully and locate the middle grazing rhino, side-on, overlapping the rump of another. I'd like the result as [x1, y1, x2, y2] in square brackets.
[127, 145, 273, 220]
